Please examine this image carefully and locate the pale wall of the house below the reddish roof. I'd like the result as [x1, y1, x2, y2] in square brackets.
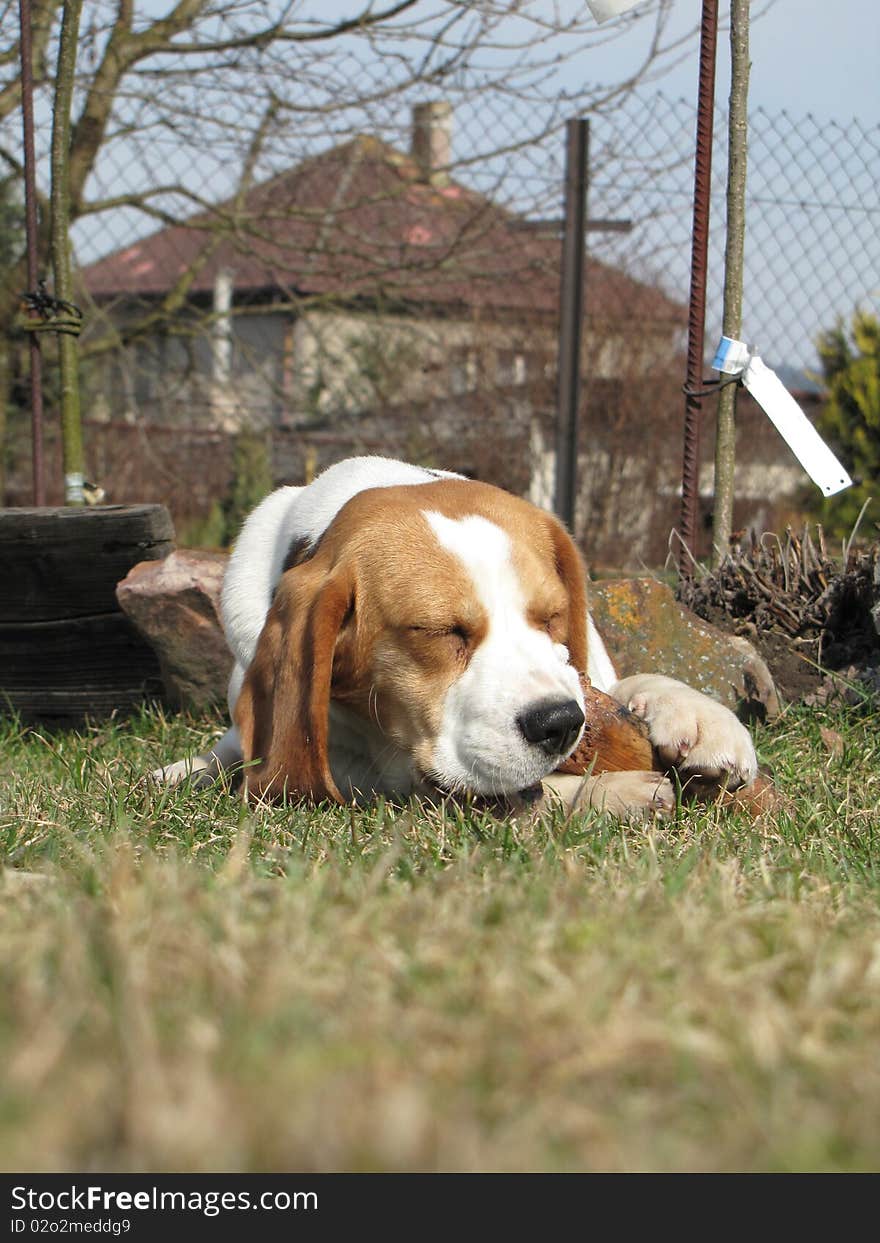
[87, 303, 675, 433]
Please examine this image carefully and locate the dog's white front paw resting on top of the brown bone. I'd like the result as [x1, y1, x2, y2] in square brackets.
[612, 674, 758, 789]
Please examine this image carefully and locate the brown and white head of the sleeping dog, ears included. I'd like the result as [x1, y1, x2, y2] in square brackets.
[235, 480, 587, 802]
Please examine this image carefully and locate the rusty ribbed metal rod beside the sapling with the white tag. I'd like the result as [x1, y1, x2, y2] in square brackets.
[679, 0, 718, 578]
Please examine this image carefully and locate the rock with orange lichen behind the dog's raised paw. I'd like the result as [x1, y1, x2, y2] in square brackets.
[590, 578, 779, 720]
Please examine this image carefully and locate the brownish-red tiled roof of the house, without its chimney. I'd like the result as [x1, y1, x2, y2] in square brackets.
[82, 135, 685, 326]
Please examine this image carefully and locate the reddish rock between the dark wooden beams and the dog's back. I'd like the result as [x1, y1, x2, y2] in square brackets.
[116, 549, 232, 711]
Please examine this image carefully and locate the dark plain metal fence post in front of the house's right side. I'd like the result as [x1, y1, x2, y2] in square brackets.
[553, 117, 589, 533]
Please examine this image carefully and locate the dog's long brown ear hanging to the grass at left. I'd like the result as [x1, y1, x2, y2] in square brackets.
[234, 557, 354, 803]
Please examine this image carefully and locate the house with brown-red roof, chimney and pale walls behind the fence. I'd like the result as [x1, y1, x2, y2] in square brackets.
[82, 102, 684, 430]
